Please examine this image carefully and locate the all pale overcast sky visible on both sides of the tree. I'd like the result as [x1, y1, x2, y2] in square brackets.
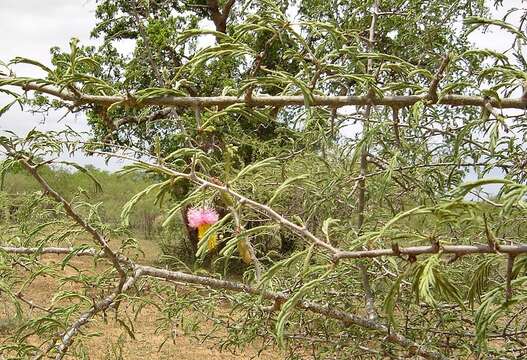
[0, 0, 525, 170]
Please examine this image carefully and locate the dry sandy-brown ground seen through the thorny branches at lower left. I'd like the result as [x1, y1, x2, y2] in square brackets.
[0, 241, 282, 360]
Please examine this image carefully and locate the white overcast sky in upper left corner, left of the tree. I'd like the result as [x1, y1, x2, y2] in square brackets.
[0, 0, 100, 126]
